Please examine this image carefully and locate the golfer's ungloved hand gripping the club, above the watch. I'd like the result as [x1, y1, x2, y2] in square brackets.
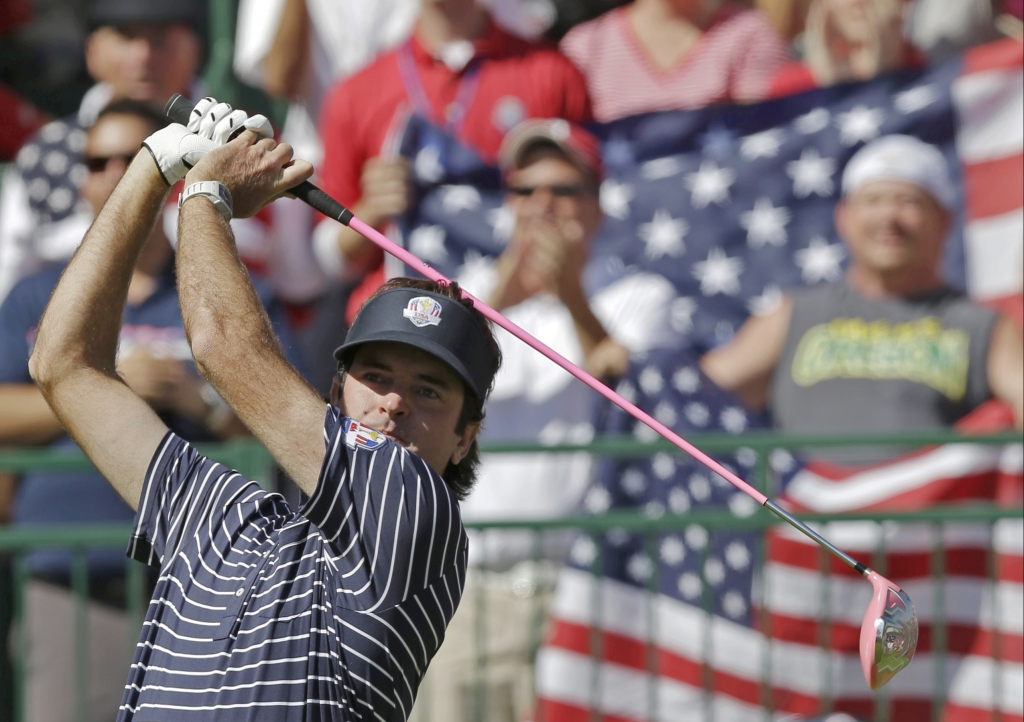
[185, 130, 313, 218]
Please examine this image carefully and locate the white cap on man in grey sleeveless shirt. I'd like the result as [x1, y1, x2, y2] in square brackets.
[843, 135, 956, 211]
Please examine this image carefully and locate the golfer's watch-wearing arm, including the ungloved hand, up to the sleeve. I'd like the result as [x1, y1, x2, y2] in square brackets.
[177, 132, 326, 494]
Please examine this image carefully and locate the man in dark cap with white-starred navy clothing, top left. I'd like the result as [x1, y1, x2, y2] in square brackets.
[0, 0, 204, 301]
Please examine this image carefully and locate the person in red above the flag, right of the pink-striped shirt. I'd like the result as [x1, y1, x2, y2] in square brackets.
[769, 0, 923, 97]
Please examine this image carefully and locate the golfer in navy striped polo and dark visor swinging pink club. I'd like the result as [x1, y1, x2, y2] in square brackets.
[30, 100, 501, 722]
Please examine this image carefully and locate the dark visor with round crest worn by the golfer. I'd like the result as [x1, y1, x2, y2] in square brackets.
[334, 288, 494, 401]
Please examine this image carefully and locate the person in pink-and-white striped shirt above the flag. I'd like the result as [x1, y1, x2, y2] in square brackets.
[561, 0, 788, 123]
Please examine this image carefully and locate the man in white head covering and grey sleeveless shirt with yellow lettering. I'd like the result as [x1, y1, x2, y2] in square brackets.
[701, 135, 1024, 461]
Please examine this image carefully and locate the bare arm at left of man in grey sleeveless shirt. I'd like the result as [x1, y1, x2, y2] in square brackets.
[700, 296, 793, 409]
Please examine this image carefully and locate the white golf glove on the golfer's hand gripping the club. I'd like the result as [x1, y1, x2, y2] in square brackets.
[142, 97, 273, 185]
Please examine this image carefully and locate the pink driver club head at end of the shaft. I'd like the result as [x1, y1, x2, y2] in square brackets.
[860, 570, 918, 689]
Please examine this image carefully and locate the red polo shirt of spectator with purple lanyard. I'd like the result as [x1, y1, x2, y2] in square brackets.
[319, 20, 591, 321]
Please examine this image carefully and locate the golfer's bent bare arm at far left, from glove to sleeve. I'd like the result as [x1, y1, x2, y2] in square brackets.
[29, 150, 168, 509]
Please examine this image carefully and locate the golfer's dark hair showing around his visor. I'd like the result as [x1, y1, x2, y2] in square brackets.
[338, 278, 502, 500]
